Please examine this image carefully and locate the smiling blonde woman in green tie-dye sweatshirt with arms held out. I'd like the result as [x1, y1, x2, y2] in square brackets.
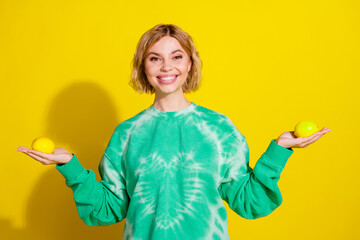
[18, 24, 330, 239]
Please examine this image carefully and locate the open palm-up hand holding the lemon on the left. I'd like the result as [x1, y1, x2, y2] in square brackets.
[16, 146, 73, 165]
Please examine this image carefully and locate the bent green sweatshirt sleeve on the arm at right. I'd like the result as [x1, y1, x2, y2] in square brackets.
[218, 137, 294, 219]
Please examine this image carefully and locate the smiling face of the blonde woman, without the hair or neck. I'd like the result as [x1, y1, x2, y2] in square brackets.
[145, 36, 191, 95]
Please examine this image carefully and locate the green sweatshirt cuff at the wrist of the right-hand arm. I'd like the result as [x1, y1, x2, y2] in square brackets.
[264, 139, 294, 166]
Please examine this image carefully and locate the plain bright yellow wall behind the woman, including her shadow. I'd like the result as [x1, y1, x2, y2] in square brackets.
[0, 0, 360, 240]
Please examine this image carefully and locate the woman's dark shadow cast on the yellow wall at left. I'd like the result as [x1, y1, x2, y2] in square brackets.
[0, 81, 125, 240]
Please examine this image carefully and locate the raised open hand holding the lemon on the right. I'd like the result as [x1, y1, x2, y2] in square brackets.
[275, 127, 331, 148]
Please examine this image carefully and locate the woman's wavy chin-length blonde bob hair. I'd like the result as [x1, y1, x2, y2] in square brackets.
[129, 24, 202, 94]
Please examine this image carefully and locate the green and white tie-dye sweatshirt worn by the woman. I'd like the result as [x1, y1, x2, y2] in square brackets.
[56, 102, 293, 240]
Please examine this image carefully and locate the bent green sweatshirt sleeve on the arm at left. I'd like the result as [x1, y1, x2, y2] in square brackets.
[56, 126, 130, 226]
